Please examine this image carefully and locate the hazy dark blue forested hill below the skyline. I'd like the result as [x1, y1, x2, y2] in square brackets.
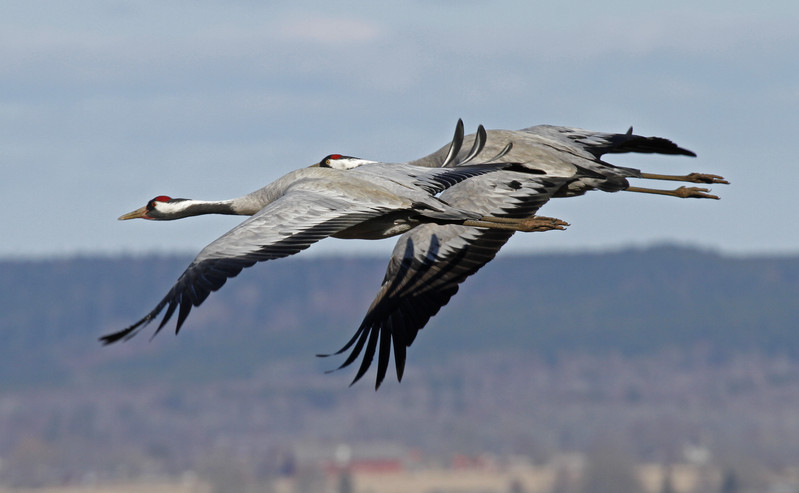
[0, 247, 799, 388]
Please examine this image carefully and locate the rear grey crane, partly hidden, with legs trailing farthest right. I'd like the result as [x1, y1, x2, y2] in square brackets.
[319, 121, 727, 388]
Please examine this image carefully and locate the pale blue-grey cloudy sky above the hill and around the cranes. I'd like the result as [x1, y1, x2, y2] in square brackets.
[0, 0, 799, 257]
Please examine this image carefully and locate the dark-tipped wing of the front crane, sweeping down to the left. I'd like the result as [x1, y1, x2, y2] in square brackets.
[100, 190, 391, 344]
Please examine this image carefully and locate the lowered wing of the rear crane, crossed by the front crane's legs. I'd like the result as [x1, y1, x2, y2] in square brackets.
[324, 171, 561, 388]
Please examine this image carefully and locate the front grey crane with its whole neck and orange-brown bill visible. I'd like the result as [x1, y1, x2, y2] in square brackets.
[100, 155, 565, 344]
